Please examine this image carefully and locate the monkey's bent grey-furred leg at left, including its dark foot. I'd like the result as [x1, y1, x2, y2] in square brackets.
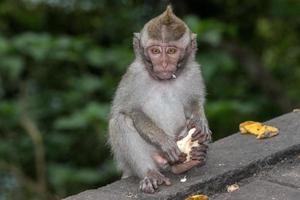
[109, 114, 170, 193]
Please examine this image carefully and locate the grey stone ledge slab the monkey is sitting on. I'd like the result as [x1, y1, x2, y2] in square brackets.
[66, 112, 300, 200]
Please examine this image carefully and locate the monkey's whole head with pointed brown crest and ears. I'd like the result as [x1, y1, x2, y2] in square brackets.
[133, 6, 197, 80]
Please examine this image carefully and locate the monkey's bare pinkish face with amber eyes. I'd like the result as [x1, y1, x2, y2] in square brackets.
[145, 42, 185, 80]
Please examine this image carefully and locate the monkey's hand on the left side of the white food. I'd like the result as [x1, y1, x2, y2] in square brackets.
[160, 136, 186, 164]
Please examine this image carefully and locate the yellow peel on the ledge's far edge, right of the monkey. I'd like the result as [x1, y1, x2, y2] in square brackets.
[240, 121, 279, 139]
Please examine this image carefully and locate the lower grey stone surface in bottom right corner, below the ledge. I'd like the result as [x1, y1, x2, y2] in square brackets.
[210, 153, 300, 200]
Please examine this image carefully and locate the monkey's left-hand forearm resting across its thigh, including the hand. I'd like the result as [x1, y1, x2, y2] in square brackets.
[129, 109, 181, 163]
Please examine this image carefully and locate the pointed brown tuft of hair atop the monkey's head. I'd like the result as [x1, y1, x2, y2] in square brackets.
[147, 5, 187, 41]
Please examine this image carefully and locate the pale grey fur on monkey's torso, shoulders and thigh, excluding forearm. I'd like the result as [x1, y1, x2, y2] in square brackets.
[109, 48, 209, 178]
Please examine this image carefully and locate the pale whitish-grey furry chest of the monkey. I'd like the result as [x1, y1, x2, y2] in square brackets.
[142, 92, 186, 136]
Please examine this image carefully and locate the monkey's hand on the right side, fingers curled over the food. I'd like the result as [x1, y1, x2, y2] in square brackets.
[187, 119, 212, 144]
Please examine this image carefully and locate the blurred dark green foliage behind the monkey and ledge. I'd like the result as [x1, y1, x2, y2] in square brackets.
[0, 0, 300, 200]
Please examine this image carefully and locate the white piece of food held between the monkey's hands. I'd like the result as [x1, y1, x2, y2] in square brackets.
[177, 128, 199, 162]
